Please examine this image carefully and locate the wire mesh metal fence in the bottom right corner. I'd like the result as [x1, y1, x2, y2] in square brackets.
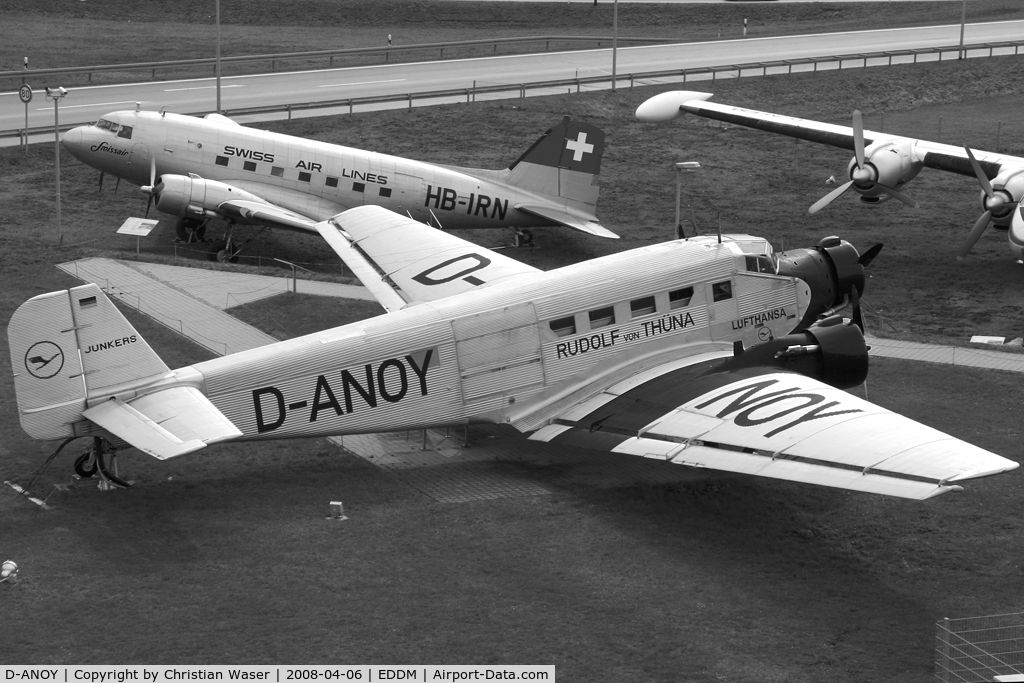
[935, 612, 1024, 683]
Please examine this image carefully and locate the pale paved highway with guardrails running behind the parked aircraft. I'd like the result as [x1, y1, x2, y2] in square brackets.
[0, 20, 1024, 135]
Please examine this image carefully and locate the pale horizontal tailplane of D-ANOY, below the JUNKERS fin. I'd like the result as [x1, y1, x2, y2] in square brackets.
[82, 386, 242, 460]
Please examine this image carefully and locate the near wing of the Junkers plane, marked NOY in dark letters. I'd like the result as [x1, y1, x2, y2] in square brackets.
[516, 351, 1018, 500]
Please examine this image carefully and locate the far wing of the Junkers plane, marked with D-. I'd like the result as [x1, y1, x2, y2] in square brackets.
[316, 206, 541, 311]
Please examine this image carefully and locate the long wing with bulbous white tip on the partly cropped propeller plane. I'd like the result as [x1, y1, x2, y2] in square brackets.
[637, 90, 1024, 179]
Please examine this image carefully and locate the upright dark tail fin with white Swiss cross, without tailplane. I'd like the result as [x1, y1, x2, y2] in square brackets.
[509, 117, 604, 209]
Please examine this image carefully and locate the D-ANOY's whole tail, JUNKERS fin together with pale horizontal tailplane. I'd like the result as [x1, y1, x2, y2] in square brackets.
[7, 285, 242, 458]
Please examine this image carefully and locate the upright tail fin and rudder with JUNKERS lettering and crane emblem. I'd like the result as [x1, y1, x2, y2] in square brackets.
[7, 284, 169, 439]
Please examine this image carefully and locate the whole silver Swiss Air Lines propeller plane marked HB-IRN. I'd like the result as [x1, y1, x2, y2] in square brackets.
[63, 111, 617, 250]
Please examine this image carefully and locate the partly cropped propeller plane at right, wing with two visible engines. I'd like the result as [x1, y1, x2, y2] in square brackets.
[636, 90, 1024, 259]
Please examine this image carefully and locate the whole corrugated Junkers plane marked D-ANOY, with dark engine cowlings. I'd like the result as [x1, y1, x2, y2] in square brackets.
[8, 207, 1017, 499]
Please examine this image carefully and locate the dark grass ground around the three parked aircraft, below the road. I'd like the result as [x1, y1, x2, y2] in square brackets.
[6, 2, 1024, 683]
